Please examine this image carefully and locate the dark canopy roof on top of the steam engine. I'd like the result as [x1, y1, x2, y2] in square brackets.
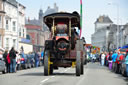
[44, 12, 80, 30]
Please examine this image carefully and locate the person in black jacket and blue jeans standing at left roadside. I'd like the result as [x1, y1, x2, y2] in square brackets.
[9, 47, 16, 73]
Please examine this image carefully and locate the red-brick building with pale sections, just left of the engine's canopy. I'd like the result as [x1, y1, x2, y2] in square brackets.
[26, 24, 45, 52]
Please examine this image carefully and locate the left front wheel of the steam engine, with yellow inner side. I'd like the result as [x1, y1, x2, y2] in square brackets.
[44, 50, 50, 76]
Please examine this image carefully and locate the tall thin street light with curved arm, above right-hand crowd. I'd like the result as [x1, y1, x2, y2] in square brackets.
[108, 3, 119, 49]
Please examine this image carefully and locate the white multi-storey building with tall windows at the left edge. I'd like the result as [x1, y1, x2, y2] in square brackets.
[0, 0, 26, 50]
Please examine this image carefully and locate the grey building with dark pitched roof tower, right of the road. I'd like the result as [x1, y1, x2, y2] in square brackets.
[91, 16, 128, 51]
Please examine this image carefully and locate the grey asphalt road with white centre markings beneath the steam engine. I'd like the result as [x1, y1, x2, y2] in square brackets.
[0, 63, 128, 85]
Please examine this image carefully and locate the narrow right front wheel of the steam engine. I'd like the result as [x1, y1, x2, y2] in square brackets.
[76, 51, 81, 76]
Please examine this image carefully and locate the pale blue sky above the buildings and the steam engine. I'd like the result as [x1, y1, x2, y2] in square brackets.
[17, 0, 128, 43]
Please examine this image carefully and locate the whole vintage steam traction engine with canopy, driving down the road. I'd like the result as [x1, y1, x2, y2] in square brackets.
[44, 12, 85, 76]
